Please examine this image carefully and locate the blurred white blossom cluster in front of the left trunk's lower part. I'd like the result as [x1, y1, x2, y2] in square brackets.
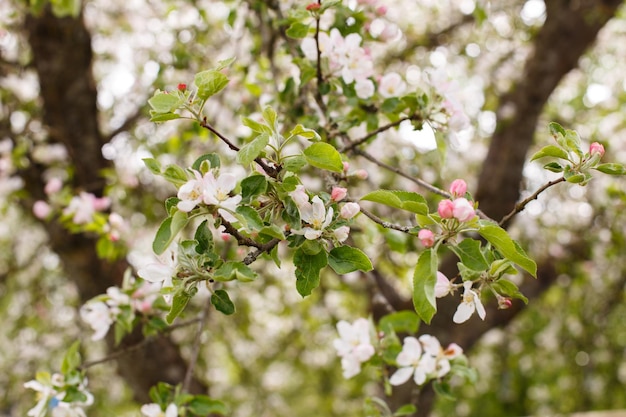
[80, 281, 159, 340]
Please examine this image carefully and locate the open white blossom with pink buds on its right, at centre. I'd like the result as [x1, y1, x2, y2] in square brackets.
[289, 185, 360, 243]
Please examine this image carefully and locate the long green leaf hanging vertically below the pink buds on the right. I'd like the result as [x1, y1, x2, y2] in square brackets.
[413, 249, 437, 324]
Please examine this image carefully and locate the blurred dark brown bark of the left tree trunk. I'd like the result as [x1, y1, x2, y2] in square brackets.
[22, 9, 206, 402]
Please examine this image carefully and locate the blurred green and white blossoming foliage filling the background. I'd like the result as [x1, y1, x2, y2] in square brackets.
[0, 0, 626, 417]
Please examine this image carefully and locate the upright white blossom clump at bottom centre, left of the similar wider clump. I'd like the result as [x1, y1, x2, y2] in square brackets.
[333, 318, 375, 378]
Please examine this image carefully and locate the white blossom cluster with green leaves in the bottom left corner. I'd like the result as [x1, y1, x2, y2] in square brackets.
[24, 372, 93, 417]
